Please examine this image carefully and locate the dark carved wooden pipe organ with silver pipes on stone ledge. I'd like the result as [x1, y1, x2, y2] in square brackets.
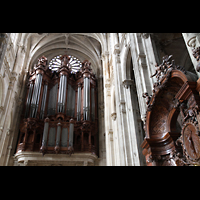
[17, 55, 98, 155]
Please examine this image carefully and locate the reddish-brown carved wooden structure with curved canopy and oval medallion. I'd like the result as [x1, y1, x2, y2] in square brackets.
[141, 56, 200, 166]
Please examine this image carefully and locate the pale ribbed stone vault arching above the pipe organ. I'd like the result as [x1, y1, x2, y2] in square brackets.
[23, 33, 106, 74]
